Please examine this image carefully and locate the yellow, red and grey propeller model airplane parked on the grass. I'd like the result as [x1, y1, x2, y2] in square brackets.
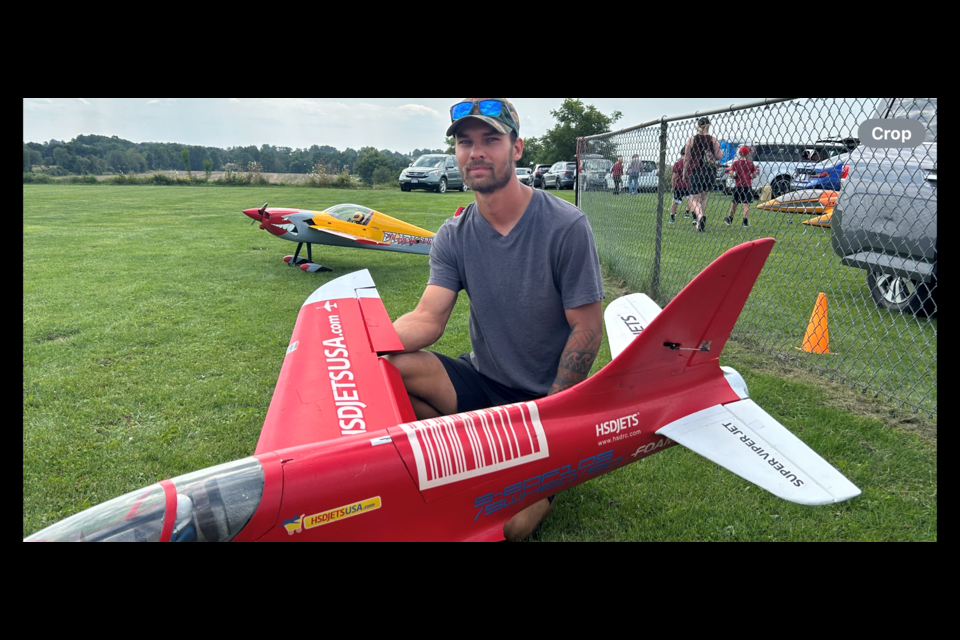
[243, 204, 434, 273]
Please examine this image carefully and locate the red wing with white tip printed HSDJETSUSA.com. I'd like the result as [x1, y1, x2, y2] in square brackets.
[256, 269, 416, 454]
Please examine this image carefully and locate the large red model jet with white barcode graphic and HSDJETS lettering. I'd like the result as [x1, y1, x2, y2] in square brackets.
[28, 239, 860, 542]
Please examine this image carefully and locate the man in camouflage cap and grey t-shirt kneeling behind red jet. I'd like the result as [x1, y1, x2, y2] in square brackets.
[390, 98, 603, 541]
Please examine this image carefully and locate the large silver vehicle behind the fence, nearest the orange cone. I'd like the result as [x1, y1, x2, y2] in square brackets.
[831, 98, 937, 316]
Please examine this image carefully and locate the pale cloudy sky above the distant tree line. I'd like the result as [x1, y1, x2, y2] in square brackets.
[23, 98, 762, 153]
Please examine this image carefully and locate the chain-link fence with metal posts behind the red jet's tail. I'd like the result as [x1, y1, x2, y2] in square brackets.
[577, 98, 937, 420]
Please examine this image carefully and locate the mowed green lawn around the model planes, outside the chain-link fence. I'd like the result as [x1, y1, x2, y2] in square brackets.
[23, 185, 937, 541]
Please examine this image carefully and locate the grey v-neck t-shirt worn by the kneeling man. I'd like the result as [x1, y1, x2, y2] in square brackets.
[429, 191, 604, 396]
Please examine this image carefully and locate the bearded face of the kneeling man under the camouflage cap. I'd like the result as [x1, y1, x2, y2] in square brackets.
[457, 119, 523, 193]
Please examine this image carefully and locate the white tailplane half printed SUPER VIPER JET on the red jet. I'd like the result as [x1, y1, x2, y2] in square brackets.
[657, 399, 860, 506]
